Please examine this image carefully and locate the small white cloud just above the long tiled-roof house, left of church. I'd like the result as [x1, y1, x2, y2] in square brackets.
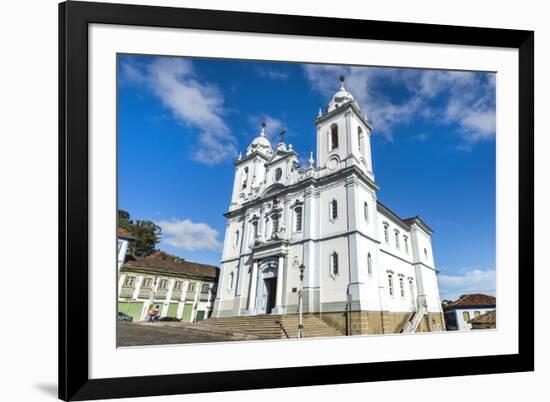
[156, 219, 221, 251]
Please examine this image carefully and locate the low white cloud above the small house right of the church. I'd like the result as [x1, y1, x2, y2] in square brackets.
[437, 268, 496, 300]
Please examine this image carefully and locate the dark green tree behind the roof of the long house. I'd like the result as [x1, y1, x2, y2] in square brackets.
[118, 209, 162, 256]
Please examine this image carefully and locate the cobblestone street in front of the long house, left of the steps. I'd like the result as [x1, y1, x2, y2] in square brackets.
[117, 321, 236, 347]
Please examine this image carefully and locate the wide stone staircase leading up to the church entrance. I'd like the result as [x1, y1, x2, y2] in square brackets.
[194, 314, 343, 339]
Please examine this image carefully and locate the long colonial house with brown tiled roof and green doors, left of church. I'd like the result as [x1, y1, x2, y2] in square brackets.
[118, 251, 219, 322]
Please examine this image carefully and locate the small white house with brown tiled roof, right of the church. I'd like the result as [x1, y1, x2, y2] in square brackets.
[443, 293, 496, 331]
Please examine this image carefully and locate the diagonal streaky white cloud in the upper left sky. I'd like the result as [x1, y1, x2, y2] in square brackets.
[122, 58, 237, 165]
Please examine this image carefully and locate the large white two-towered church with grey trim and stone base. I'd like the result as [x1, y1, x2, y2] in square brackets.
[213, 76, 444, 334]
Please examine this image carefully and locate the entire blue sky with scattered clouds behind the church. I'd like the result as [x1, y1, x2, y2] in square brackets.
[118, 55, 495, 298]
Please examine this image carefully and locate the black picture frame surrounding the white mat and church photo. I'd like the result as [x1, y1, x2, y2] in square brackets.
[59, 1, 534, 400]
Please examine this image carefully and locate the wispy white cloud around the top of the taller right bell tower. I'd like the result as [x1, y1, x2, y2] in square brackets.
[304, 65, 496, 149]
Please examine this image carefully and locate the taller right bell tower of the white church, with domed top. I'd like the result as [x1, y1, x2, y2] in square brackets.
[315, 75, 374, 180]
